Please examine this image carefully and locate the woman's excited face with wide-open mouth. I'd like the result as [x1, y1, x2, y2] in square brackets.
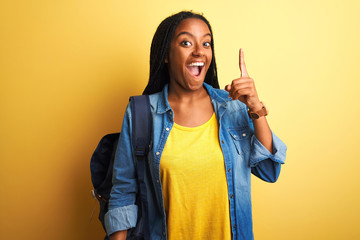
[165, 18, 212, 91]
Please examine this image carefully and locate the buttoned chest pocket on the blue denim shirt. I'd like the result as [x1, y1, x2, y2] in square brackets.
[229, 127, 252, 155]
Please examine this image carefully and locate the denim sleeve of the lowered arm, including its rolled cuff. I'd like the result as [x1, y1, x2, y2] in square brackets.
[105, 104, 138, 235]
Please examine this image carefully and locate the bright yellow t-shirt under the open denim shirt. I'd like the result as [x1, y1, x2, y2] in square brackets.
[160, 114, 231, 240]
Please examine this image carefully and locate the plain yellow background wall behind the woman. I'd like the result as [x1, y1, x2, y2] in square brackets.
[0, 0, 360, 240]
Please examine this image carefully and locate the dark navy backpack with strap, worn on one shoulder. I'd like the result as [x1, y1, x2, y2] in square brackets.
[90, 95, 152, 240]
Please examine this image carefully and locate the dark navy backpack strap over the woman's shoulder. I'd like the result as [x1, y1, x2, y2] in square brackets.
[130, 95, 152, 239]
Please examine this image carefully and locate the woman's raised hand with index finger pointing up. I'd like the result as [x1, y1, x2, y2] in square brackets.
[225, 48, 262, 111]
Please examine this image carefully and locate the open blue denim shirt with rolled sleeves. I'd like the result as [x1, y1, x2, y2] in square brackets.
[105, 83, 287, 240]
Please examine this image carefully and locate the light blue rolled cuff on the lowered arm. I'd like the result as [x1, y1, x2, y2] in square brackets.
[105, 205, 138, 236]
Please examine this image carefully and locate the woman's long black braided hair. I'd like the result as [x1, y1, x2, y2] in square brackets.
[143, 11, 219, 94]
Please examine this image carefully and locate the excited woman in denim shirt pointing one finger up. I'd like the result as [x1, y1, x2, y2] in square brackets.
[105, 12, 286, 239]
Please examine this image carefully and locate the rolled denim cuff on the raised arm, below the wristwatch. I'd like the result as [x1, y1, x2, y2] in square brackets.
[250, 131, 287, 167]
